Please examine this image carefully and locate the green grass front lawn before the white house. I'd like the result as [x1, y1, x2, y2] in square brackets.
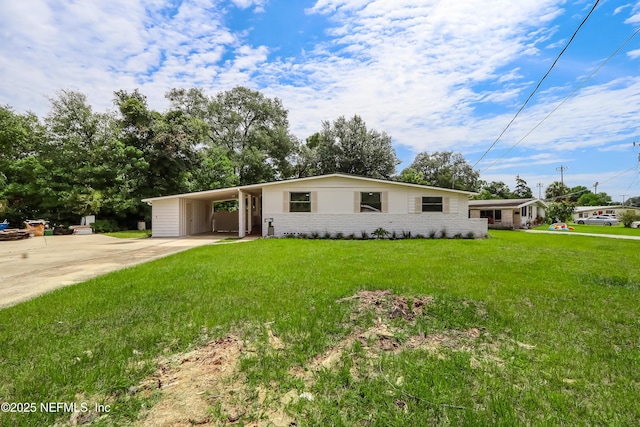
[0, 232, 640, 426]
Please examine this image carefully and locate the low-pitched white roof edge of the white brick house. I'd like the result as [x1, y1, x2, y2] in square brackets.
[142, 173, 476, 203]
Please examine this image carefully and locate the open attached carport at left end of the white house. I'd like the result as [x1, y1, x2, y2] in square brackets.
[142, 184, 262, 237]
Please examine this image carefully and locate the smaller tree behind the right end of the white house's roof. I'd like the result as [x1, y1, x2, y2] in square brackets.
[401, 151, 480, 191]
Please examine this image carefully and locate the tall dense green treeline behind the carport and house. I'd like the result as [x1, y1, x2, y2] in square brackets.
[0, 87, 416, 227]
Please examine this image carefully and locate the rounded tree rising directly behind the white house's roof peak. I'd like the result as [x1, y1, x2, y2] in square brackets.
[307, 115, 400, 179]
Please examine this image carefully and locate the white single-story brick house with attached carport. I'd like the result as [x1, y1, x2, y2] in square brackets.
[143, 174, 487, 241]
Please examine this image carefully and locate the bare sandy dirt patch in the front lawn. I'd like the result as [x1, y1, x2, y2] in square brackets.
[131, 290, 500, 427]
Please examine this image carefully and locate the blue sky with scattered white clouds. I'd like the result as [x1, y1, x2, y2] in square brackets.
[0, 0, 640, 200]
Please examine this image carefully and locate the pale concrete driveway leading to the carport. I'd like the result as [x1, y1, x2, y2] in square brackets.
[0, 234, 246, 307]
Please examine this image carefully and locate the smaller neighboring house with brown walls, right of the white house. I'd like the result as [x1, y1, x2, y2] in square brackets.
[469, 199, 547, 229]
